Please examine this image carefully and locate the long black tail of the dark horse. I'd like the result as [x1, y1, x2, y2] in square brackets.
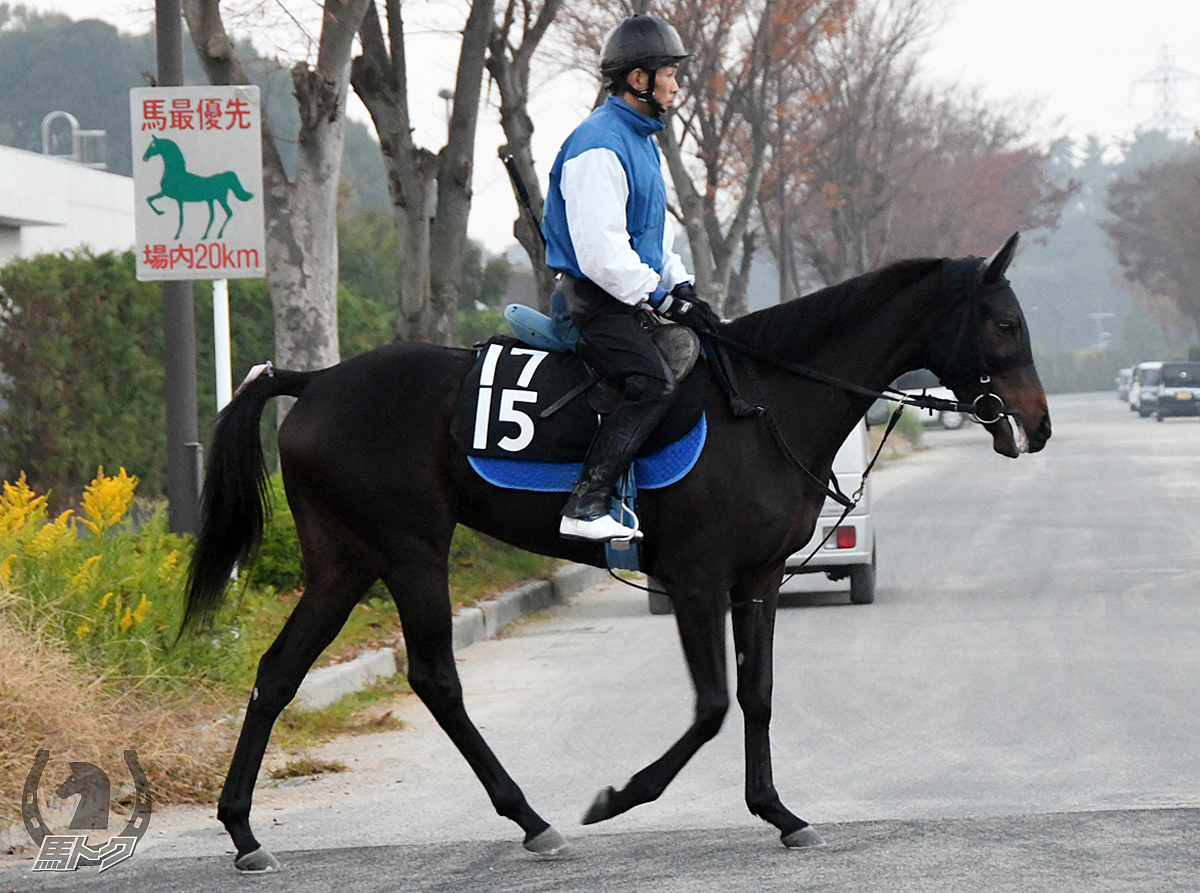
[180, 366, 317, 635]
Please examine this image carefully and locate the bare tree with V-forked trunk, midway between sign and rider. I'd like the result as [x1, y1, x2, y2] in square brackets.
[350, 0, 494, 344]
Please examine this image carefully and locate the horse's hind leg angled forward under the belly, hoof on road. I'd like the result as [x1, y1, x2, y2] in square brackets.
[384, 556, 568, 856]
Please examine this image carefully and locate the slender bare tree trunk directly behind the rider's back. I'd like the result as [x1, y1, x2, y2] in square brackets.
[487, 0, 563, 310]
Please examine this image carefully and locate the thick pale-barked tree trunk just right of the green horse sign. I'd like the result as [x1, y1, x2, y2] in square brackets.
[182, 0, 368, 379]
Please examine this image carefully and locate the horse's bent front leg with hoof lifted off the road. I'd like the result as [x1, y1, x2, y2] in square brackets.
[583, 592, 730, 825]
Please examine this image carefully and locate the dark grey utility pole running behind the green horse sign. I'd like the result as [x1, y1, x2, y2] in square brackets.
[155, 0, 203, 533]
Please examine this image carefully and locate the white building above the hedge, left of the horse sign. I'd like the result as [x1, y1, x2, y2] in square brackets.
[0, 145, 134, 266]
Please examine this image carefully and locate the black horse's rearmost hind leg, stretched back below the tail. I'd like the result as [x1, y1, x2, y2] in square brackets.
[217, 564, 377, 871]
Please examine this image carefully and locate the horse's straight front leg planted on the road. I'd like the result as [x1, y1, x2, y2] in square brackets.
[731, 568, 824, 846]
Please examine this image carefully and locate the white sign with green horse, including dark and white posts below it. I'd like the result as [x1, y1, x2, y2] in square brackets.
[130, 85, 266, 523]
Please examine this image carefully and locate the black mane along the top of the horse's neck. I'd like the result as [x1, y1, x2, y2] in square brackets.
[724, 258, 946, 358]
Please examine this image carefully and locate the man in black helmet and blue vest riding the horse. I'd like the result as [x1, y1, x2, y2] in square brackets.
[542, 16, 713, 541]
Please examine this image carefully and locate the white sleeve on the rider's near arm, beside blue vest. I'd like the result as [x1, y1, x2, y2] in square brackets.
[560, 149, 659, 305]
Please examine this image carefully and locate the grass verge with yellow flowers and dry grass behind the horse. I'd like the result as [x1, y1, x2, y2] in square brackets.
[0, 471, 558, 845]
